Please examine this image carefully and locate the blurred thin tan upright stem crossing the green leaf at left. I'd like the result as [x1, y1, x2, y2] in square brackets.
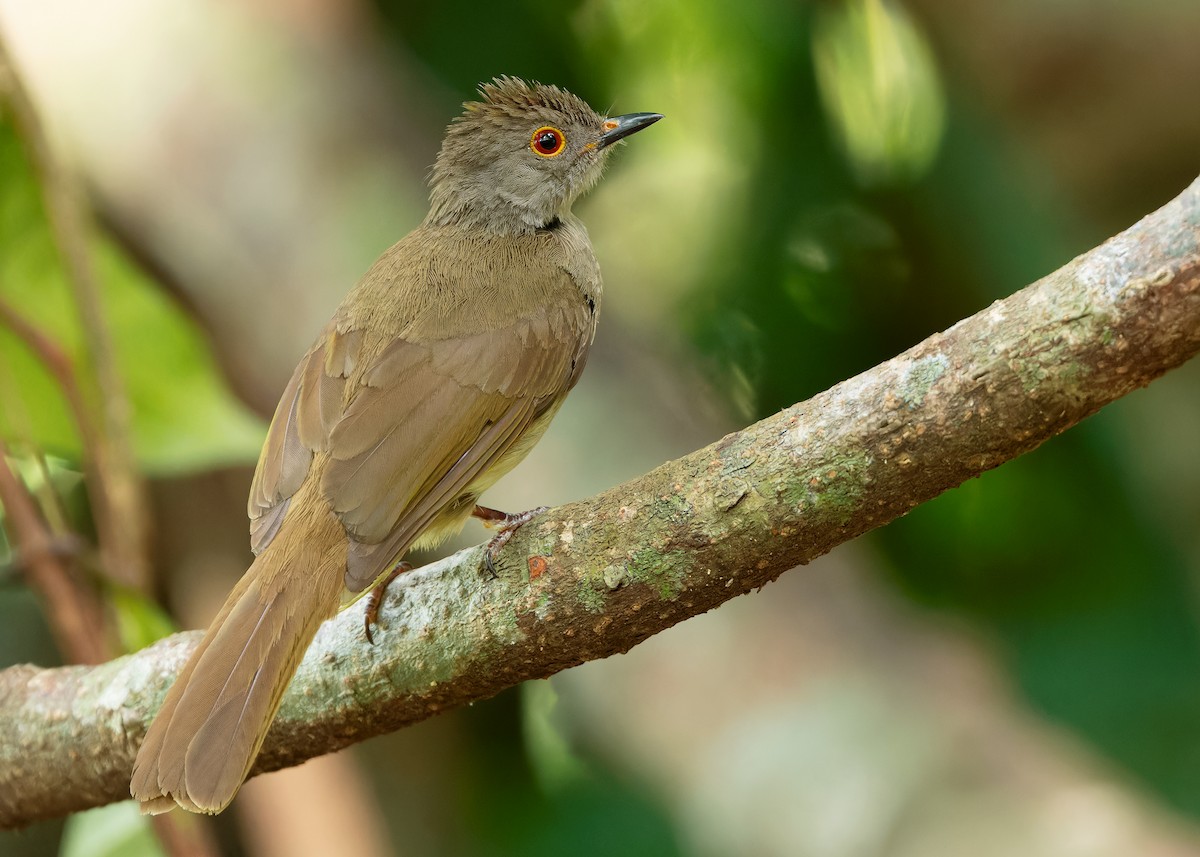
[0, 26, 149, 589]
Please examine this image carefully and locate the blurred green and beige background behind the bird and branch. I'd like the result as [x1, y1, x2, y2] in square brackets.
[0, 0, 1200, 857]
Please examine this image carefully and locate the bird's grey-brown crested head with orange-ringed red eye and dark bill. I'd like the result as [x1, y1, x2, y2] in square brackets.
[426, 77, 662, 233]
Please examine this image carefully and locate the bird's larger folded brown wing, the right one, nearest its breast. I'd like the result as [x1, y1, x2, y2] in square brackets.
[322, 298, 590, 592]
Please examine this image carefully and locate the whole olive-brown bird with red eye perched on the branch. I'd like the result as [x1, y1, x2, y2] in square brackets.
[130, 77, 661, 813]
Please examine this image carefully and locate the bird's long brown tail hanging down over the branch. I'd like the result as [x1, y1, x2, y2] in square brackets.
[130, 506, 344, 814]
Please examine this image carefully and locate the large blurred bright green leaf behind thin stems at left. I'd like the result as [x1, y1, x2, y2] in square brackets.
[0, 110, 265, 474]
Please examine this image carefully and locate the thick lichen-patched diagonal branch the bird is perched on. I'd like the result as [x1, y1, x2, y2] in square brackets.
[0, 180, 1200, 827]
